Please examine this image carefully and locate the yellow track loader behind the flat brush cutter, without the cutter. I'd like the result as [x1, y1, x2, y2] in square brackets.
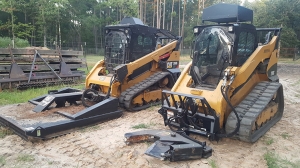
[82, 18, 181, 111]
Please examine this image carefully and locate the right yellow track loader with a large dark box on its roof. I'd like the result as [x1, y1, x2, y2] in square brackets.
[159, 3, 284, 142]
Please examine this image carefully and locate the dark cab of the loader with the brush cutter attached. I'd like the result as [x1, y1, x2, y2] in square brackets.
[104, 17, 157, 72]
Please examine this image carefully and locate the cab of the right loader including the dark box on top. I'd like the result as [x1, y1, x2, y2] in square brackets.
[190, 3, 258, 90]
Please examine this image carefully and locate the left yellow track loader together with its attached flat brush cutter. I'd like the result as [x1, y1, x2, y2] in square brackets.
[0, 17, 181, 140]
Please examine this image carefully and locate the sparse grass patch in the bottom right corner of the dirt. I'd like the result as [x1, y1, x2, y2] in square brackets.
[264, 151, 300, 168]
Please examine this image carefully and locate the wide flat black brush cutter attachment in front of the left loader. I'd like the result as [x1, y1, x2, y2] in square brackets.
[0, 88, 123, 141]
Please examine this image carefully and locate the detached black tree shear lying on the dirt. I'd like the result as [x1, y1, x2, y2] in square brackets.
[125, 130, 212, 162]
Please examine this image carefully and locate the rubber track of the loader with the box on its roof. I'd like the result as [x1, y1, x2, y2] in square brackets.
[225, 82, 283, 142]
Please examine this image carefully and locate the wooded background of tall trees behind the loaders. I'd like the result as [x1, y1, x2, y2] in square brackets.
[0, 0, 300, 54]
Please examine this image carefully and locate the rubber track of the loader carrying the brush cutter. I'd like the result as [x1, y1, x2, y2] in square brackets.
[119, 72, 170, 111]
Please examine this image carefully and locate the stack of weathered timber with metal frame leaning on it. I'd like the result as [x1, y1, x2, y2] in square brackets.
[0, 48, 86, 91]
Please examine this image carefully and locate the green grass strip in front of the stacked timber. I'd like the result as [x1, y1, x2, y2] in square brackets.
[0, 84, 84, 105]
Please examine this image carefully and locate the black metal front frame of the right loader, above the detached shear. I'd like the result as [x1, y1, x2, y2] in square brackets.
[158, 90, 220, 140]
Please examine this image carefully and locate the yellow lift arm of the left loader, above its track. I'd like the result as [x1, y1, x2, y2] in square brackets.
[114, 38, 181, 82]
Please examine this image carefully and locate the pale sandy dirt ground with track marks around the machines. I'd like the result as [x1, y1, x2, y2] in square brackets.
[0, 64, 300, 168]
